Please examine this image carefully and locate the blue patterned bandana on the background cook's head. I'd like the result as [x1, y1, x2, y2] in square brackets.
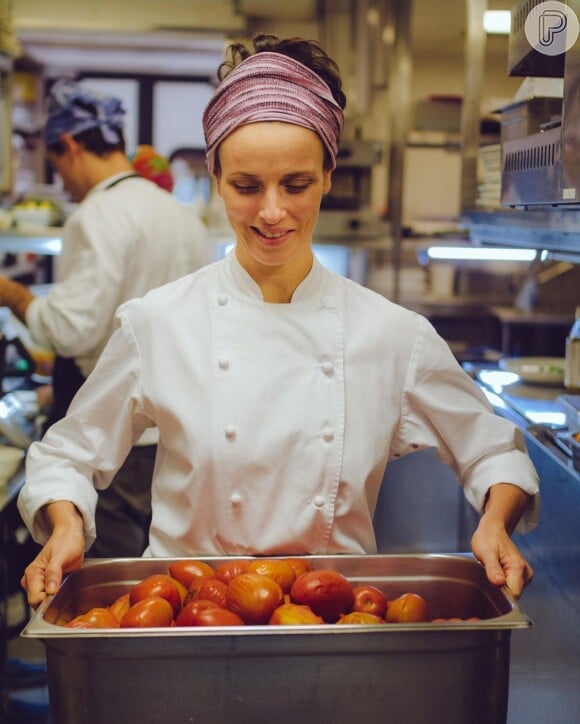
[42, 80, 125, 146]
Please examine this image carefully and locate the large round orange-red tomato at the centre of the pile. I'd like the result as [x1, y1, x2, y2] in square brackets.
[227, 573, 284, 624]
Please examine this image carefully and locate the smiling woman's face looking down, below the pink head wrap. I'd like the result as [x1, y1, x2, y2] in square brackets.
[217, 122, 331, 274]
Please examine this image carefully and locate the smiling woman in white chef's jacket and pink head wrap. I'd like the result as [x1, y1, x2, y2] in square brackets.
[19, 35, 538, 605]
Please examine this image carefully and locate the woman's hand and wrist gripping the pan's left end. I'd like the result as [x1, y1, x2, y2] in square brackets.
[20, 501, 85, 608]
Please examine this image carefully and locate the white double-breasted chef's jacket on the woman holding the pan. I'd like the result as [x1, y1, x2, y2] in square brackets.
[19, 254, 538, 557]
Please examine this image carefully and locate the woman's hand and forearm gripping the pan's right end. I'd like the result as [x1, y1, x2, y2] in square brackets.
[471, 483, 534, 599]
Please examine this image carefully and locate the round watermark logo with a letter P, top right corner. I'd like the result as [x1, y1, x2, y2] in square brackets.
[524, 0, 580, 55]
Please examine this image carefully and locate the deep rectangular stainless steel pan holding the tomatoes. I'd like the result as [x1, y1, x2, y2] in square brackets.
[22, 554, 532, 724]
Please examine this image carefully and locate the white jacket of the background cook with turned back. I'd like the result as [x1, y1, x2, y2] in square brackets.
[26, 173, 208, 377]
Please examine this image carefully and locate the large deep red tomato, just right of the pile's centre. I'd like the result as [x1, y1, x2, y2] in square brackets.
[290, 569, 354, 623]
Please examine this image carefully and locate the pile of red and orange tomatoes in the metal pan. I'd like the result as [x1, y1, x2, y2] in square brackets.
[63, 558, 478, 628]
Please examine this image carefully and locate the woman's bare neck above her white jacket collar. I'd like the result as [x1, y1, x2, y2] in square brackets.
[236, 246, 313, 304]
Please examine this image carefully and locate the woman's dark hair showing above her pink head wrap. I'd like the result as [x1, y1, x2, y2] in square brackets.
[218, 33, 346, 109]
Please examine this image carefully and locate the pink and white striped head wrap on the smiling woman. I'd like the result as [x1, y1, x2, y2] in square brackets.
[203, 51, 344, 176]
